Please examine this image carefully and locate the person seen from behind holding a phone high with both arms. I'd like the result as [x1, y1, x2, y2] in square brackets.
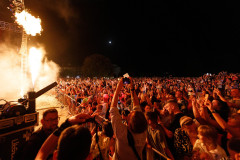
[110, 78, 147, 160]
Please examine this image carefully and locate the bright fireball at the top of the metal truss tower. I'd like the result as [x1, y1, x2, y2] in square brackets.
[15, 10, 42, 36]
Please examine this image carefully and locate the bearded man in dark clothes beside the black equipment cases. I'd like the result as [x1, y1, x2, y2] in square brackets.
[20, 109, 59, 160]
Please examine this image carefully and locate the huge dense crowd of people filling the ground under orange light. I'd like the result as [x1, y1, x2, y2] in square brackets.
[17, 72, 240, 160]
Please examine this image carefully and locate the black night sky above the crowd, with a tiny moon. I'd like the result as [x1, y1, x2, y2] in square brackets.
[0, 0, 240, 76]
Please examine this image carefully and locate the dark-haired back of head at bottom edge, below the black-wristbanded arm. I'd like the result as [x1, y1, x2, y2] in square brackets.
[57, 125, 92, 160]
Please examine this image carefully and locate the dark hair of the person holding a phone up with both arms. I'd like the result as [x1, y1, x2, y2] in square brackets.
[128, 111, 148, 133]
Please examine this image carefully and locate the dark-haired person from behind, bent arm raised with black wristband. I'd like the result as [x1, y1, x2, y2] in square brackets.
[35, 113, 92, 160]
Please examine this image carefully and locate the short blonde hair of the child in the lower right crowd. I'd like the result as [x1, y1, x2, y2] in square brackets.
[198, 125, 218, 143]
